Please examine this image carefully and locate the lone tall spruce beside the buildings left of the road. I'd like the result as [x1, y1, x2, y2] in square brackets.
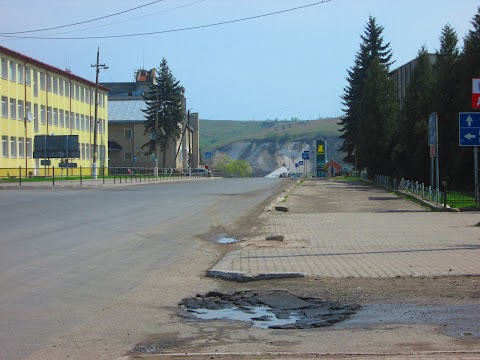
[142, 58, 184, 167]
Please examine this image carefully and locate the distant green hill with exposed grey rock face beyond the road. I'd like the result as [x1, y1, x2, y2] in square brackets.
[200, 118, 345, 171]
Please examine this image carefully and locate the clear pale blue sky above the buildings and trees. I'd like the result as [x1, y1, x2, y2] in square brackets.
[0, 0, 480, 120]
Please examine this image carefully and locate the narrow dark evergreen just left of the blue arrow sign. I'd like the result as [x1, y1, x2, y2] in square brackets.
[433, 25, 460, 186]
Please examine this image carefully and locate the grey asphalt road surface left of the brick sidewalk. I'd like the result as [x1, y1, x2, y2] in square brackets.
[0, 178, 279, 360]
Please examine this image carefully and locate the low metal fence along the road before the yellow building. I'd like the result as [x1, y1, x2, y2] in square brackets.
[0, 166, 214, 186]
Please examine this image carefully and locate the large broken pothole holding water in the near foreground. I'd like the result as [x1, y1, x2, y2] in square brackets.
[179, 290, 359, 329]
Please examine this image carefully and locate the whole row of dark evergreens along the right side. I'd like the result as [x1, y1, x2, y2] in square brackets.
[340, 7, 480, 189]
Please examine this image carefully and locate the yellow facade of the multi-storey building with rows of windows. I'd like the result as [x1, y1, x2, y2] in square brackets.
[0, 49, 108, 177]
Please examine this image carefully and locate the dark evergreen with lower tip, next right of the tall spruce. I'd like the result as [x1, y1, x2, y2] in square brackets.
[394, 47, 435, 182]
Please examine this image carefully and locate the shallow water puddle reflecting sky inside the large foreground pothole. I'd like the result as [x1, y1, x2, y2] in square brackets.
[188, 306, 301, 329]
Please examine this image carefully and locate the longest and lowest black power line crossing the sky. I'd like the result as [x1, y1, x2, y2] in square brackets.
[0, 0, 333, 40]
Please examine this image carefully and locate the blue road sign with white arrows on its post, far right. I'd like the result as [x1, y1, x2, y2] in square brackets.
[458, 112, 480, 204]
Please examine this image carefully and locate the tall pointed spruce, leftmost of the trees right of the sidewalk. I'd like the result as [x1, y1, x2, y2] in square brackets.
[340, 17, 397, 174]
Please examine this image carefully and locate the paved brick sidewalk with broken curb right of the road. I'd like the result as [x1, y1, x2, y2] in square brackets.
[209, 180, 480, 281]
